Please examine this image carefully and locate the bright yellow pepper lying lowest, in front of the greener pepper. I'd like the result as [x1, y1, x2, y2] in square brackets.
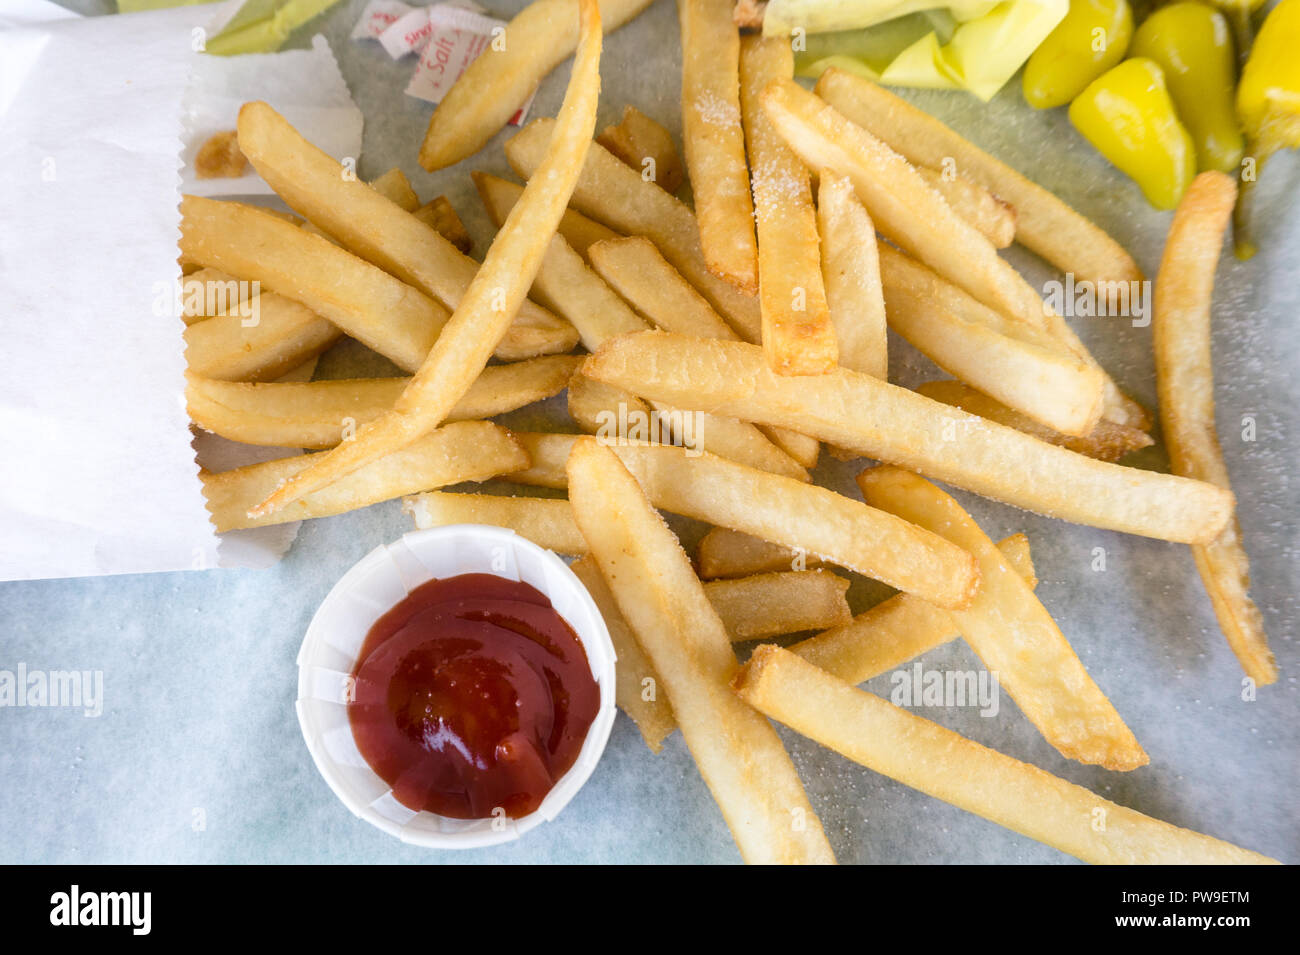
[1070, 59, 1190, 209]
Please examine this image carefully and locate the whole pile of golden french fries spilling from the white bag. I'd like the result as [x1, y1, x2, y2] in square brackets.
[182, 0, 1277, 863]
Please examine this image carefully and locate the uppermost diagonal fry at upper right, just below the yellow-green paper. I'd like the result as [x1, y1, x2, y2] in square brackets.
[816, 68, 1141, 289]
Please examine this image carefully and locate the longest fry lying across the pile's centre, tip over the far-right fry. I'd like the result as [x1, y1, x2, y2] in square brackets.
[582, 331, 1232, 543]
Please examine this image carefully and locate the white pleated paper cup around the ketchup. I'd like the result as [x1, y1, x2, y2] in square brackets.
[296, 524, 616, 848]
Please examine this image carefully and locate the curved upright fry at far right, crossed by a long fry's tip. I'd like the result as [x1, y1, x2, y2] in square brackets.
[1152, 172, 1278, 685]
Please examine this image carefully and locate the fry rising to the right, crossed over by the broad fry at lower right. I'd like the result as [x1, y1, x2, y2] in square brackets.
[788, 534, 1039, 685]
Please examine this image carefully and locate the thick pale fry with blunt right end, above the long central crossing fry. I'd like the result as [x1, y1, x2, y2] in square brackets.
[880, 247, 1105, 437]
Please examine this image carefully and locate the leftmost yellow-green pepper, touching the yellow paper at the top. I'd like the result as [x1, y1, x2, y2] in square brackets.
[1023, 0, 1134, 109]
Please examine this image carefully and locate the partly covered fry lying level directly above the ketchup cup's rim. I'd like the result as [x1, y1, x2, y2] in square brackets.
[403, 488, 588, 556]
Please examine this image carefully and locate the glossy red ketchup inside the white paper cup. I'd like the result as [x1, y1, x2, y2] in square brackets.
[347, 574, 601, 819]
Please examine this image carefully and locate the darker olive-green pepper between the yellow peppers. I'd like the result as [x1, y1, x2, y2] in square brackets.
[1128, 3, 1245, 173]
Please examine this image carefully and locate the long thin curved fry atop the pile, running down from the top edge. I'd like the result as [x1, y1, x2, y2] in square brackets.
[252, 0, 601, 517]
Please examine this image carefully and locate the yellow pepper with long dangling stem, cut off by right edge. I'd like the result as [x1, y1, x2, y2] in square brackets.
[1234, 0, 1300, 259]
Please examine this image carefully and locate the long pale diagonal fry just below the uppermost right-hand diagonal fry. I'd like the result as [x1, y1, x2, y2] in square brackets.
[763, 81, 1047, 327]
